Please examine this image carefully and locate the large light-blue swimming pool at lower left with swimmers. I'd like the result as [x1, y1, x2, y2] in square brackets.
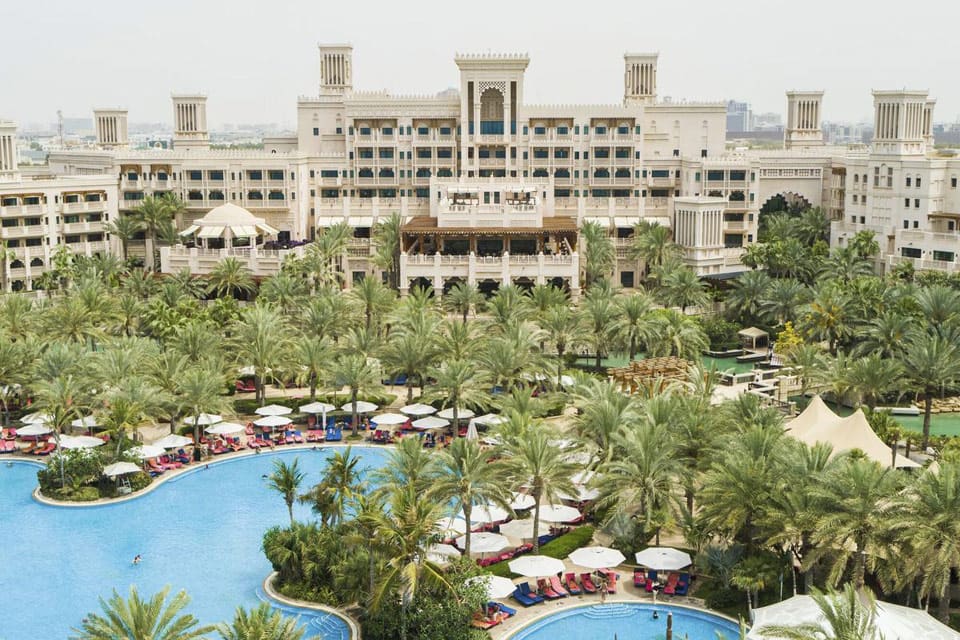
[0, 447, 387, 640]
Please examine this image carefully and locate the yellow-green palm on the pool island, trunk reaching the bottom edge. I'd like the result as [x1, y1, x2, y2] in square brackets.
[370, 486, 453, 640]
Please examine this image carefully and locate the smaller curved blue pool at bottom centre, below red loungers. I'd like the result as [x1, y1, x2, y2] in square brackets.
[510, 602, 740, 640]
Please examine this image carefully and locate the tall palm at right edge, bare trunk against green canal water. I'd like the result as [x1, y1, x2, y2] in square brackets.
[901, 333, 960, 450]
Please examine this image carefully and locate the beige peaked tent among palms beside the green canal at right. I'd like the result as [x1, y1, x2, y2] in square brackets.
[786, 396, 920, 468]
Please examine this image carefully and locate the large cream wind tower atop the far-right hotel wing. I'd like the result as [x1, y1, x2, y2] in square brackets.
[873, 90, 933, 155]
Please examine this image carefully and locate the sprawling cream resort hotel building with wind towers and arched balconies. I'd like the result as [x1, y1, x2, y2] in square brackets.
[0, 45, 960, 296]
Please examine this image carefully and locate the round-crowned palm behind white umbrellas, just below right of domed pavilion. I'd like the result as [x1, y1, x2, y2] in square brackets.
[233, 304, 293, 404]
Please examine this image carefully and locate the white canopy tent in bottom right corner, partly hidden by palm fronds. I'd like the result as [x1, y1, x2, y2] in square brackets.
[747, 596, 960, 640]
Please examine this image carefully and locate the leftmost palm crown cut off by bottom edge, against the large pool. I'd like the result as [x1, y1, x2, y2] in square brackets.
[74, 586, 213, 640]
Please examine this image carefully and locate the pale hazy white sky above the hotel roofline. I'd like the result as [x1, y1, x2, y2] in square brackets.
[0, 0, 960, 126]
